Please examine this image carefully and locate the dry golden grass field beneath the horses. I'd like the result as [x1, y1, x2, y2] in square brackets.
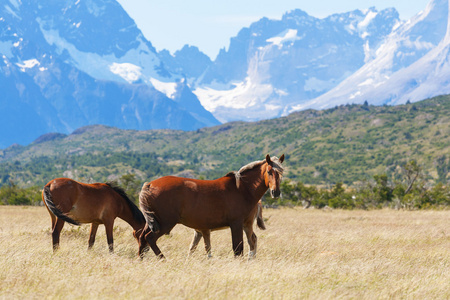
[0, 206, 450, 299]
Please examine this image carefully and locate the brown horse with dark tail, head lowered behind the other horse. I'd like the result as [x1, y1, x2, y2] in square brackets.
[42, 178, 145, 252]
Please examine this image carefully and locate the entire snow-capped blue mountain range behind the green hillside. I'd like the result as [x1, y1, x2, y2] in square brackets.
[0, 0, 450, 148]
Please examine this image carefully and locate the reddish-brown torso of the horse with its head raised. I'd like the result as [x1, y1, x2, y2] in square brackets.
[139, 176, 246, 229]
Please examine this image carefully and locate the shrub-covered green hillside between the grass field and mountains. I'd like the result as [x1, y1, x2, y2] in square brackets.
[0, 96, 450, 186]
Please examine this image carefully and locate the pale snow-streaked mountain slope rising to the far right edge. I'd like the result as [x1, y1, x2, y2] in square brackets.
[294, 0, 450, 110]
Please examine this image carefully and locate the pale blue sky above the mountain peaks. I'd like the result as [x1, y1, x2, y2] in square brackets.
[118, 0, 430, 60]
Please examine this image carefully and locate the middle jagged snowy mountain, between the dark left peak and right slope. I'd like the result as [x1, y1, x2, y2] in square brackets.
[192, 8, 400, 122]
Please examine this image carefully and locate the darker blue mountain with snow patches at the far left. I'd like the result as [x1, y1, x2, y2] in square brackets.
[0, 0, 219, 148]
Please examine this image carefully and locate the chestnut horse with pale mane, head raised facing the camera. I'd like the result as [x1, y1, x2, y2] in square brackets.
[139, 154, 284, 258]
